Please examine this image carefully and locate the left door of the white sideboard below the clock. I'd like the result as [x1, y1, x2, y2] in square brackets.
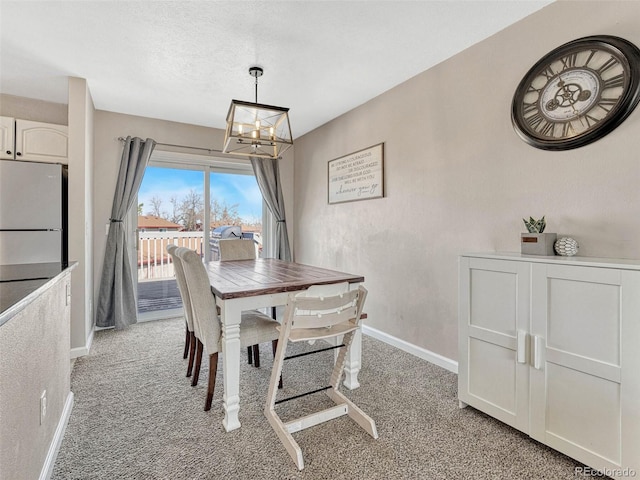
[458, 257, 530, 432]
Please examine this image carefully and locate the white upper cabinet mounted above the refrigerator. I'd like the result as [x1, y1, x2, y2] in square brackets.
[0, 117, 69, 164]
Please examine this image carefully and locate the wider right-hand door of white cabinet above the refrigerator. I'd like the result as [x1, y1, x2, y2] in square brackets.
[16, 120, 69, 164]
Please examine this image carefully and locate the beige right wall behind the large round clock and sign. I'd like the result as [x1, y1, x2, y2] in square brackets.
[294, 1, 640, 359]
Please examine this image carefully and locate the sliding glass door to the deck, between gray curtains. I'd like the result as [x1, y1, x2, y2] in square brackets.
[133, 152, 263, 321]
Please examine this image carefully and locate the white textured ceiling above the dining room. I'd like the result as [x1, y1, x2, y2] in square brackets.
[0, 0, 553, 137]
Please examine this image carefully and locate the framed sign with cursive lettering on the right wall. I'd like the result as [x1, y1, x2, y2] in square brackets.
[328, 143, 384, 204]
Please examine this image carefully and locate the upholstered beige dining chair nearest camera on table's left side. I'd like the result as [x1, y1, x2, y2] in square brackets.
[176, 247, 278, 411]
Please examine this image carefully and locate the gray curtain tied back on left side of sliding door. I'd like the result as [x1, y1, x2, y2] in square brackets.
[96, 137, 156, 328]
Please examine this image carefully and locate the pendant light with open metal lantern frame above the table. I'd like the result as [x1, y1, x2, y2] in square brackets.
[222, 67, 293, 158]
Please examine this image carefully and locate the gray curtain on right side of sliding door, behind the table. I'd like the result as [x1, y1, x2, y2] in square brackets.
[249, 157, 291, 261]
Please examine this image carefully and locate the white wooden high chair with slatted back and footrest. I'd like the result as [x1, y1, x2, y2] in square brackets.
[264, 285, 378, 470]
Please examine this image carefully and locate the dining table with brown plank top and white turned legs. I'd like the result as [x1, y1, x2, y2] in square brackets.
[205, 258, 364, 432]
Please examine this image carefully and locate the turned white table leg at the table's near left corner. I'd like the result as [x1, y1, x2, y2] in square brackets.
[220, 300, 242, 432]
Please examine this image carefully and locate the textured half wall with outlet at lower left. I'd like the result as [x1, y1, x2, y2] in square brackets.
[0, 270, 70, 480]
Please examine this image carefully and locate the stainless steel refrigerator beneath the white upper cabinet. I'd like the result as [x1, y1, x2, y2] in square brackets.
[0, 160, 68, 265]
